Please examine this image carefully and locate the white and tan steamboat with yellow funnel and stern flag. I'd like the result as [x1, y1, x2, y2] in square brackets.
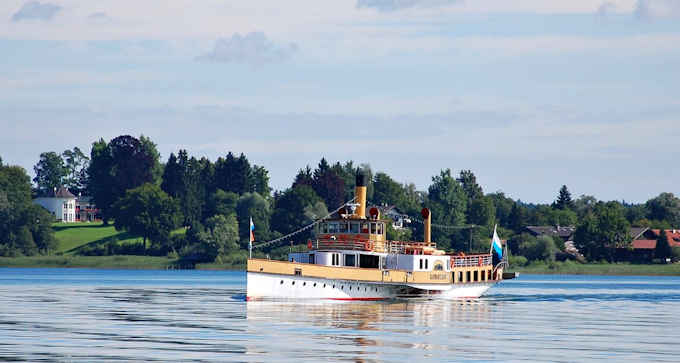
[246, 172, 514, 300]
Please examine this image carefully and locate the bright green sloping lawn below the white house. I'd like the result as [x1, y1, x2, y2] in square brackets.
[53, 222, 141, 254]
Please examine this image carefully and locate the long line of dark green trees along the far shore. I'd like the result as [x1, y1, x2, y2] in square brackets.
[0, 135, 680, 262]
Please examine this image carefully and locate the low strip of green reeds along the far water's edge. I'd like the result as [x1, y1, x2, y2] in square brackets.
[0, 255, 680, 276]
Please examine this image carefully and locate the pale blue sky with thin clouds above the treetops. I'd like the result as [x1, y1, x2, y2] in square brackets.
[0, 0, 680, 203]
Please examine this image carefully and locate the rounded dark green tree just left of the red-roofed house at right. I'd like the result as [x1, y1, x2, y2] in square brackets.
[574, 202, 632, 261]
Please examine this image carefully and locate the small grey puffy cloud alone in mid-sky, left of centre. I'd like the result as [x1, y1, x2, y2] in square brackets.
[197, 32, 298, 65]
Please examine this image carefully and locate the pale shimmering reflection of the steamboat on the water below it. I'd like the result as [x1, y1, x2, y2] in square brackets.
[246, 299, 492, 360]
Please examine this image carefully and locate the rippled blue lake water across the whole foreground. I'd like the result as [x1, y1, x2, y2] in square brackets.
[0, 269, 680, 362]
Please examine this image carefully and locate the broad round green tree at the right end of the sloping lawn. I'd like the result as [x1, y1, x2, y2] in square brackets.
[113, 183, 181, 248]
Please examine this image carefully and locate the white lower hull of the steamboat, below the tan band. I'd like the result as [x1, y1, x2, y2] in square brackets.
[246, 272, 495, 300]
